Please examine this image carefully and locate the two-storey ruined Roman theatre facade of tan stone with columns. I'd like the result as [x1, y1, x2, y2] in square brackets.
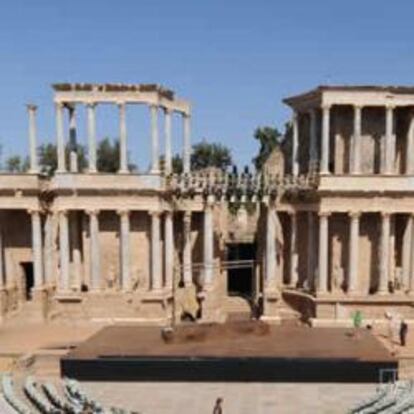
[0, 84, 414, 325]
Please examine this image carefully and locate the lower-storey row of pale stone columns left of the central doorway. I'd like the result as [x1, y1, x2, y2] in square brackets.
[18, 202, 214, 294]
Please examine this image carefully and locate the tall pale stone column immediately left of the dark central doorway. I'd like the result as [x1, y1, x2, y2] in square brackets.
[203, 195, 214, 288]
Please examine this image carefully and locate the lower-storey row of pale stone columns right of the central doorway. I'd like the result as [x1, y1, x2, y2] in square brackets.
[264, 205, 414, 296]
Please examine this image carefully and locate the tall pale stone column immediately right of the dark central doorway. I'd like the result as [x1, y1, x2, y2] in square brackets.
[265, 202, 277, 290]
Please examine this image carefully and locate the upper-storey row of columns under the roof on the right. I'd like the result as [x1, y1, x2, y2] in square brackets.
[292, 105, 414, 176]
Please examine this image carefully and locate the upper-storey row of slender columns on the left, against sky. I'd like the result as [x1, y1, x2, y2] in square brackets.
[27, 102, 191, 174]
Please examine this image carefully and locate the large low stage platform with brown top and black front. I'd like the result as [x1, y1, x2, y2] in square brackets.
[61, 322, 397, 382]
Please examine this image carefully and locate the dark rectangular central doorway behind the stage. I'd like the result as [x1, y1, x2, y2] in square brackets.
[227, 243, 256, 299]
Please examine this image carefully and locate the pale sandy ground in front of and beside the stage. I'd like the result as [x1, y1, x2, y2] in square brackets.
[0, 323, 402, 414]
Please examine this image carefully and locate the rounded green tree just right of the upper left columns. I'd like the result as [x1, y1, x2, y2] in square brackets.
[191, 141, 233, 170]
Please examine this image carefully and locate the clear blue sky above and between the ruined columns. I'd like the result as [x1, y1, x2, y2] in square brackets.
[0, 0, 414, 168]
